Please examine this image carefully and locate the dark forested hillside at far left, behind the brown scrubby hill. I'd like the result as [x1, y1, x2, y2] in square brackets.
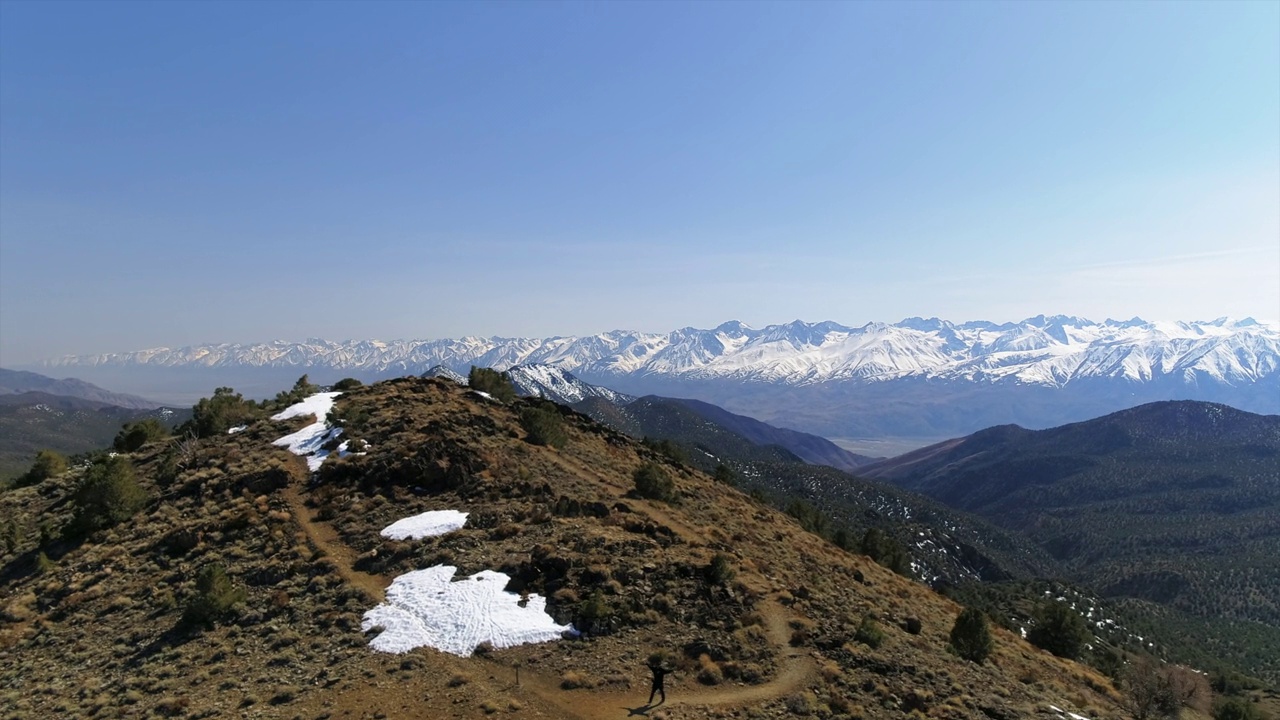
[0, 392, 191, 480]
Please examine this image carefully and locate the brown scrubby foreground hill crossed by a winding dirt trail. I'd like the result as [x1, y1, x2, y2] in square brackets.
[0, 378, 1123, 720]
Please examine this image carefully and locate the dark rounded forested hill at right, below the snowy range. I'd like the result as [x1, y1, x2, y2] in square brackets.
[860, 402, 1280, 678]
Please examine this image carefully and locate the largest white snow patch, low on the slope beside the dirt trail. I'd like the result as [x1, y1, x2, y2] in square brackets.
[361, 565, 576, 657]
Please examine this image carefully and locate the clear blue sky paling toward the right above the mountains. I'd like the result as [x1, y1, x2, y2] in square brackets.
[0, 0, 1280, 366]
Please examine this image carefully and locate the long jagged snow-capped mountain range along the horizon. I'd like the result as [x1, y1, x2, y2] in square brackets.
[41, 315, 1280, 387]
